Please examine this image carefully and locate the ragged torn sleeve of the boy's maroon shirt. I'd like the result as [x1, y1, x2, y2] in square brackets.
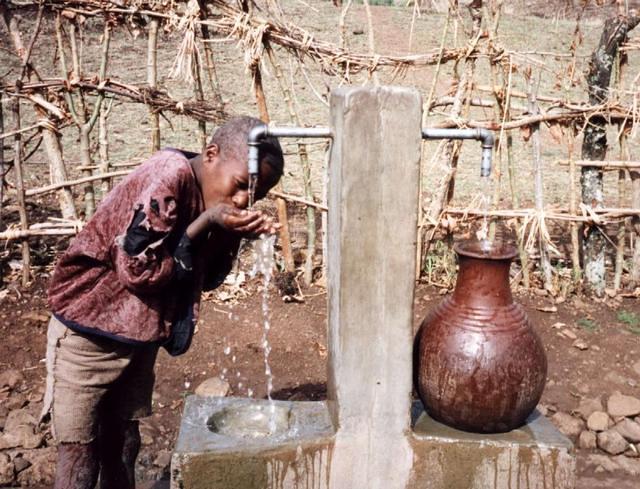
[112, 183, 179, 293]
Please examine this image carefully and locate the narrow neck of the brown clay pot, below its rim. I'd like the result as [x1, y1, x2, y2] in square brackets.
[453, 255, 513, 308]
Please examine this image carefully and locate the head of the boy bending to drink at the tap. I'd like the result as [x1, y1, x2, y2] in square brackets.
[199, 116, 284, 209]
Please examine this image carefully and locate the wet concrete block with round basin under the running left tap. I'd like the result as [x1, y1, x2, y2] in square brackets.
[171, 396, 335, 489]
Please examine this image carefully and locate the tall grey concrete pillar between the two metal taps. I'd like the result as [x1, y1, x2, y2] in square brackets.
[328, 87, 422, 489]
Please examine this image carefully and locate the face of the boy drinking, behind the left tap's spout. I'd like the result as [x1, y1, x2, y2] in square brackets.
[202, 144, 279, 209]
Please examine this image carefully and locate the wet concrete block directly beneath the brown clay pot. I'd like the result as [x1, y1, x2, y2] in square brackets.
[410, 403, 576, 489]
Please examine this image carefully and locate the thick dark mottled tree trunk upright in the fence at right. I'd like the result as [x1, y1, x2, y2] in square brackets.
[580, 16, 640, 297]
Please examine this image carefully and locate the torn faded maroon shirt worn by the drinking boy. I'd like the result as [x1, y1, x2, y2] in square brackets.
[49, 149, 239, 343]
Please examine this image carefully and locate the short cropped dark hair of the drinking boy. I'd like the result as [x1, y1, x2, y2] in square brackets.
[209, 116, 284, 178]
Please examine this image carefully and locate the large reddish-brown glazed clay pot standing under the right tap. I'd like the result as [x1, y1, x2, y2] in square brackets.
[416, 241, 547, 433]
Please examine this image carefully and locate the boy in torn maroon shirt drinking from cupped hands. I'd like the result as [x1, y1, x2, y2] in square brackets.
[45, 117, 284, 489]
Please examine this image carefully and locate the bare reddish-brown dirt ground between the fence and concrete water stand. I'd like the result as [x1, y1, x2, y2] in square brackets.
[0, 235, 640, 489]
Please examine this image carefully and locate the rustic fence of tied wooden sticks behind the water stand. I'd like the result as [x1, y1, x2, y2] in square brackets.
[0, 0, 640, 294]
